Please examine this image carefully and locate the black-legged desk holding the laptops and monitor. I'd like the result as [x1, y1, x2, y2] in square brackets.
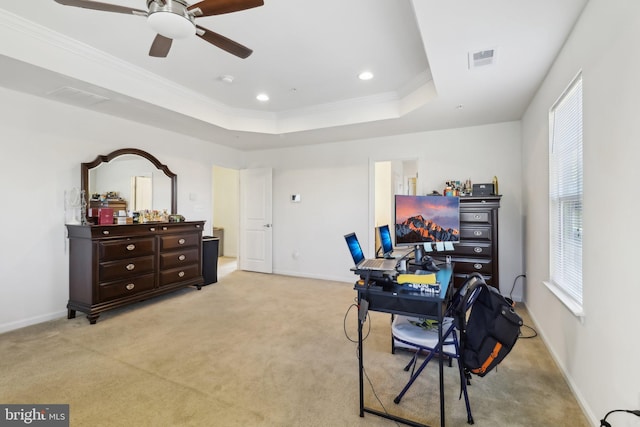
[355, 264, 453, 427]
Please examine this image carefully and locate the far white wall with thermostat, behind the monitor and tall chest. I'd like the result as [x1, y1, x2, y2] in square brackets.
[246, 122, 524, 286]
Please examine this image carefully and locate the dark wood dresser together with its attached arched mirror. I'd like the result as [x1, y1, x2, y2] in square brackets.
[67, 148, 204, 324]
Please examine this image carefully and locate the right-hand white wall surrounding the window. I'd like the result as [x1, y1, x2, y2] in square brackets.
[522, 0, 640, 426]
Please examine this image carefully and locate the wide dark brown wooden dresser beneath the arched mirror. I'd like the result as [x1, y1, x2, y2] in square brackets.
[67, 221, 204, 324]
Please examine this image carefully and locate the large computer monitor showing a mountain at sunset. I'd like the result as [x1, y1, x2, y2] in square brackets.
[395, 195, 460, 256]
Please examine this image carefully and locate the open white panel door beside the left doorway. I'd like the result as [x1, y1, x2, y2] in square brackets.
[238, 169, 273, 273]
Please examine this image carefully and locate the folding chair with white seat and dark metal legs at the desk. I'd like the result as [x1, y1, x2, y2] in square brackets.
[391, 273, 484, 424]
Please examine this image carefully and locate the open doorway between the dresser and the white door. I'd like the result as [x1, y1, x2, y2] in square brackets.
[211, 166, 240, 278]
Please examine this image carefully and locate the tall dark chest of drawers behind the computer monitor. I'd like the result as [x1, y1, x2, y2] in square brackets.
[438, 195, 502, 289]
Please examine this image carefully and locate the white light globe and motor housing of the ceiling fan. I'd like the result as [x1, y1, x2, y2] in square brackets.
[147, 0, 196, 39]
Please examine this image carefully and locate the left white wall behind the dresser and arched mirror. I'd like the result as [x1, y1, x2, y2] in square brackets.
[0, 88, 242, 332]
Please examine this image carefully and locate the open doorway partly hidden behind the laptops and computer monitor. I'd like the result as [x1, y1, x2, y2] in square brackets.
[373, 159, 418, 255]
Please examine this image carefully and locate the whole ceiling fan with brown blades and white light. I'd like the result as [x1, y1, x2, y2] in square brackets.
[55, 0, 264, 58]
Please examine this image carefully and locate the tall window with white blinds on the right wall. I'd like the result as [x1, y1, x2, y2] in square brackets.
[547, 75, 583, 316]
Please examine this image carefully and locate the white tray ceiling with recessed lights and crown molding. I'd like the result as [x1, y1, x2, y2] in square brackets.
[0, 0, 587, 150]
